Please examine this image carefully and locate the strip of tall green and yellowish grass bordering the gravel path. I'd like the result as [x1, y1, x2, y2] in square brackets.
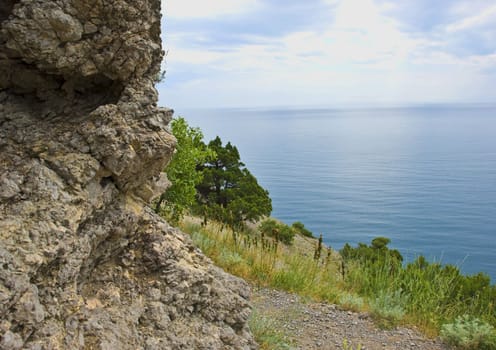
[181, 221, 496, 336]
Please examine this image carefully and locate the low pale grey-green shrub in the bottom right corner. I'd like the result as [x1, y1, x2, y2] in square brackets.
[441, 315, 496, 350]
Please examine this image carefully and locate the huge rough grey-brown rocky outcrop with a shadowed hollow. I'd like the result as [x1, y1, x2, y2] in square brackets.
[0, 0, 256, 349]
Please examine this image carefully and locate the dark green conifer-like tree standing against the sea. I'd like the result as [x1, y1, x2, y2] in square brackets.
[196, 137, 272, 230]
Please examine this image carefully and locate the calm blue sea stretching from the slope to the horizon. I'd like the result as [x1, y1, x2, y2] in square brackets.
[176, 106, 496, 283]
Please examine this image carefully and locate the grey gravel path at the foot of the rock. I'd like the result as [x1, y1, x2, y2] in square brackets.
[252, 288, 448, 350]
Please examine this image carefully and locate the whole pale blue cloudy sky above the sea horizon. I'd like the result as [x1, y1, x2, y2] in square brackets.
[158, 0, 496, 108]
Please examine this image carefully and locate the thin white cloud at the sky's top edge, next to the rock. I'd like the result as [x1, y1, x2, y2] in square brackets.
[162, 0, 260, 19]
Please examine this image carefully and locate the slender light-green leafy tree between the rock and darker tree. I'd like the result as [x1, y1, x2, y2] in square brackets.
[155, 117, 214, 223]
